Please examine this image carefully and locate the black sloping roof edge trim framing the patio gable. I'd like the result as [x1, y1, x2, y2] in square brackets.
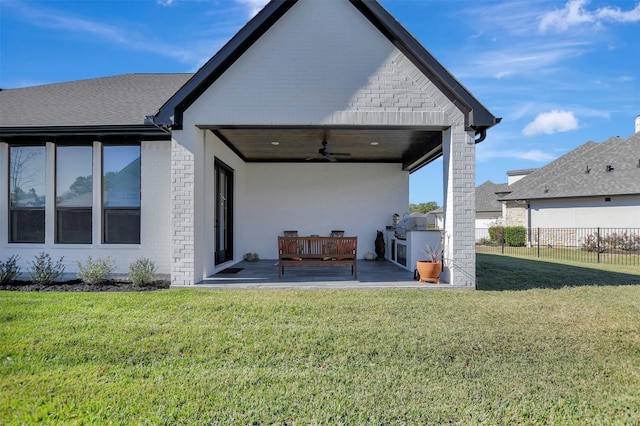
[154, 0, 500, 133]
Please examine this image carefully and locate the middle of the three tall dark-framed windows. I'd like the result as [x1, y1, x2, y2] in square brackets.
[56, 146, 93, 244]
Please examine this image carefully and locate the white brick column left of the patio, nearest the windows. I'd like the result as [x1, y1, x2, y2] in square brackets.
[171, 136, 195, 285]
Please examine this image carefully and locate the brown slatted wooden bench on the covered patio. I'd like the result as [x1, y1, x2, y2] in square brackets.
[278, 237, 358, 278]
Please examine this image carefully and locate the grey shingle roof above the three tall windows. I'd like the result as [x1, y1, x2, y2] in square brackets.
[0, 74, 193, 129]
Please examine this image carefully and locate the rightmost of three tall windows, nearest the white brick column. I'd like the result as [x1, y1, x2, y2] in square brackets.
[102, 145, 140, 244]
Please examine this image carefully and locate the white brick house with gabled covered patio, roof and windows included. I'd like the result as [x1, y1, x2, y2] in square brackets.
[0, 0, 499, 287]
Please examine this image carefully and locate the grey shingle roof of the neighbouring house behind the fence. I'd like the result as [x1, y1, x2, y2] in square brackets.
[501, 133, 640, 201]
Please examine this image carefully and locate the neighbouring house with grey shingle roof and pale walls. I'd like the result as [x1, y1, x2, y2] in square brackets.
[500, 129, 640, 228]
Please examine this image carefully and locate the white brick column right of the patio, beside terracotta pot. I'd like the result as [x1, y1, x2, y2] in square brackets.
[443, 123, 476, 288]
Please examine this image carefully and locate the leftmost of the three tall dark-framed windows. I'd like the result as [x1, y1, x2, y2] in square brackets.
[9, 146, 46, 243]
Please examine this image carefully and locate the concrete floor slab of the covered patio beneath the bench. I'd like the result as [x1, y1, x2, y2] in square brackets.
[180, 259, 462, 290]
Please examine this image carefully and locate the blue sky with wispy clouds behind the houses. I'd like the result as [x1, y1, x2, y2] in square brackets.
[0, 0, 640, 204]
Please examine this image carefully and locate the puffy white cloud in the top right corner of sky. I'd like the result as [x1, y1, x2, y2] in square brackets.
[538, 0, 640, 33]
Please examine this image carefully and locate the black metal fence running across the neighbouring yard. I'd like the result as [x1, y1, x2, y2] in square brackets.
[476, 227, 640, 266]
